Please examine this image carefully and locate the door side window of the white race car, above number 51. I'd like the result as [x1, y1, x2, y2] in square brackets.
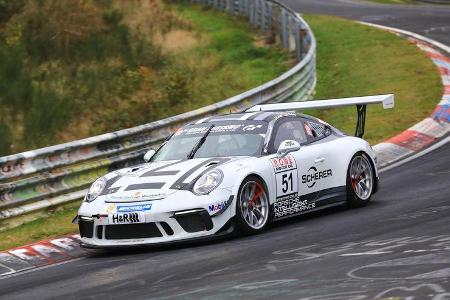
[270, 119, 307, 152]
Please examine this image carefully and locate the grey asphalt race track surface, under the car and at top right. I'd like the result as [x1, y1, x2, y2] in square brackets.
[0, 0, 450, 300]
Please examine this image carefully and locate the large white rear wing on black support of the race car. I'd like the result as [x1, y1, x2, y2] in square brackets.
[247, 94, 394, 137]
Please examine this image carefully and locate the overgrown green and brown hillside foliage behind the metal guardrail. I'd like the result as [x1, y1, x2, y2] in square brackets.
[0, 0, 290, 154]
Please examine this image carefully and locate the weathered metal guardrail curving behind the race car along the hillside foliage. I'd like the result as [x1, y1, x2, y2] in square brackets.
[0, 0, 316, 219]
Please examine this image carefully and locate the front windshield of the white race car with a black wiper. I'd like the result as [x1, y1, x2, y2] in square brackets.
[152, 121, 267, 161]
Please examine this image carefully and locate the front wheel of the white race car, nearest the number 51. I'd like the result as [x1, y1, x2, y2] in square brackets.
[236, 176, 270, 234]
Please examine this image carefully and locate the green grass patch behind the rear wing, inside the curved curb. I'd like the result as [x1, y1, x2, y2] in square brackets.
[305, 15, 443, 143]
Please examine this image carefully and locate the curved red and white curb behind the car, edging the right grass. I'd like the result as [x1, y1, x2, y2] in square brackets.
[360, 22, 450, 167]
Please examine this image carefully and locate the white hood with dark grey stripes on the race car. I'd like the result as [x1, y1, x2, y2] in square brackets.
[103, 157, 242, 203]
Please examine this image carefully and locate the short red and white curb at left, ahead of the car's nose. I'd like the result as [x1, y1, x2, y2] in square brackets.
[0, 235, 88, 277]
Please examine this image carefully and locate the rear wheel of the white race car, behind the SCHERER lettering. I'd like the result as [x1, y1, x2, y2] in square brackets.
[347, 153, 375, 208]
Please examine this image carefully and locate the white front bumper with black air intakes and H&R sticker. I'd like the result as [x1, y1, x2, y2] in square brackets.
[77, 193, 234, 248]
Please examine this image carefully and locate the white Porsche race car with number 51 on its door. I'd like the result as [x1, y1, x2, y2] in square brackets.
[75, 95, 394, 248]
